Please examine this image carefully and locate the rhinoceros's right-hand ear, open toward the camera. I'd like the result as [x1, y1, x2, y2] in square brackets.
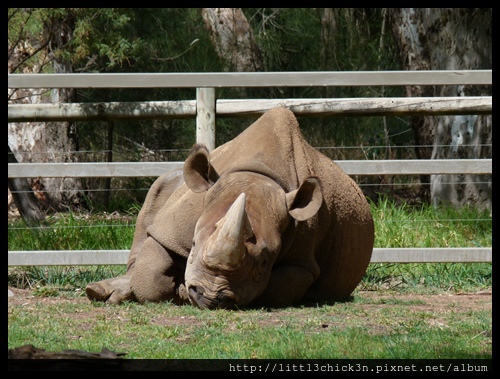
[286, 177, 323, 221]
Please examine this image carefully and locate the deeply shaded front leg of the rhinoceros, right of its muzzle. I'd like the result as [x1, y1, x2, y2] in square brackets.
[254, 266, 314, 308]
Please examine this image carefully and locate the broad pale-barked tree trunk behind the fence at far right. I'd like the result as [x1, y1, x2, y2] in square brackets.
[389, 8, 492, 209]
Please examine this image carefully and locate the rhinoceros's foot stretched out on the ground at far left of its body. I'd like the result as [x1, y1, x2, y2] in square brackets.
[85, 276, 135, 304]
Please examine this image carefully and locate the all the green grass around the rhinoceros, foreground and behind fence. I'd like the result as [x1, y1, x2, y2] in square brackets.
[8, 200, 492, 359]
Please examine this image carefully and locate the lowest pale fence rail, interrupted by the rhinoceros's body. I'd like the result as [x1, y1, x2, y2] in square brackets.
[8, 247, 492, 266]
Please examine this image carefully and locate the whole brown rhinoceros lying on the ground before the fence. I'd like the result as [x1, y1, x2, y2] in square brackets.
[86, 107, 374, 309]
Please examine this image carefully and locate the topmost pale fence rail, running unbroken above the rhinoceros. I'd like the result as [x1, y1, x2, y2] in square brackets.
[7, 70, 493, 88]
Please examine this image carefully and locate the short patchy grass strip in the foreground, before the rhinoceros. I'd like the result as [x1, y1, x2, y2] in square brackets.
[8, 290, 491, 359]
